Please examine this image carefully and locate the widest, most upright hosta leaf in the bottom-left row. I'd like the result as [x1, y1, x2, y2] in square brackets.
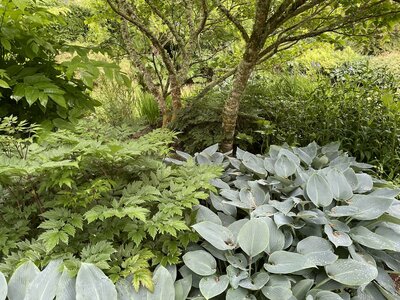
[76, 263, 117, 300]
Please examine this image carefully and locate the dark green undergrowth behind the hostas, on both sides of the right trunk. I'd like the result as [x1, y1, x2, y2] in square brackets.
[173, 63, 400, 179]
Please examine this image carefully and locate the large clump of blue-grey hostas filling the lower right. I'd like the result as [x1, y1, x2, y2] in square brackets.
[170, 143, 400, 300]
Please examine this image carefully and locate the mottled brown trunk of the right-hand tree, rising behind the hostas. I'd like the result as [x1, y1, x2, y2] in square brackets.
[220, 49, 258, 152]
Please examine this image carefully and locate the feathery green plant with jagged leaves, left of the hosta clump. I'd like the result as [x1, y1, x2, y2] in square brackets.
[0, 118, 221, 292]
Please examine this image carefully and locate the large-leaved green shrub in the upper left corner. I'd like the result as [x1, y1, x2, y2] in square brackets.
[0, 0, 126, 127]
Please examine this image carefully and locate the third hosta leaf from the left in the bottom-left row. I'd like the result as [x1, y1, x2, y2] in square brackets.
[24, 260, 61, 300]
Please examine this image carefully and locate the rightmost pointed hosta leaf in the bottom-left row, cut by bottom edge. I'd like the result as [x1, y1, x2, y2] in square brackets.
[147, 266, 175, 300]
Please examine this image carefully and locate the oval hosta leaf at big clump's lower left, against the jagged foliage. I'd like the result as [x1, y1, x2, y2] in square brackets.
[182, 250, 217, 276]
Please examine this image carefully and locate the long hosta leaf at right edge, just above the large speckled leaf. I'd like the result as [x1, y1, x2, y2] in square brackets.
[350, 226, 400, 251]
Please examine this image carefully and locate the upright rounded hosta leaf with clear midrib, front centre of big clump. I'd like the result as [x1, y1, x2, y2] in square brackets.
[238, 219, 269, 256]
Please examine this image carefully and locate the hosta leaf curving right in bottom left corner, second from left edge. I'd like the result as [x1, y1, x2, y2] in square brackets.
[7, 261, 40, 300]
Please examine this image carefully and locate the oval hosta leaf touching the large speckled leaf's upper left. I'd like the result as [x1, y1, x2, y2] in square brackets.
[296, 236, 338, 266]
